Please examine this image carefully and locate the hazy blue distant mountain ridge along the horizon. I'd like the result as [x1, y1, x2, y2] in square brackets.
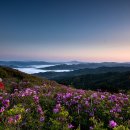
[0, 61, 130, 69]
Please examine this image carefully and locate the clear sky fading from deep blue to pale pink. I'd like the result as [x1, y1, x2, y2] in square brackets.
[0, 0, 130, 62]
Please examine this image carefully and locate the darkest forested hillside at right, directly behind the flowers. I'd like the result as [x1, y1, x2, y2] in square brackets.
[56, 71, 130, 92]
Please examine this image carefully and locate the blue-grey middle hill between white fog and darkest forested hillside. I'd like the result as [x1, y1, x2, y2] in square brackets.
[34, 66, 130, 80]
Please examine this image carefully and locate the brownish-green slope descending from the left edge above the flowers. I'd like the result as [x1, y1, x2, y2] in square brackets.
[0, 66, 58, 91]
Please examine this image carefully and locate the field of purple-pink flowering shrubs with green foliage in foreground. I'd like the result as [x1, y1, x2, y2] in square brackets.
[0, 80, 130, 130]
